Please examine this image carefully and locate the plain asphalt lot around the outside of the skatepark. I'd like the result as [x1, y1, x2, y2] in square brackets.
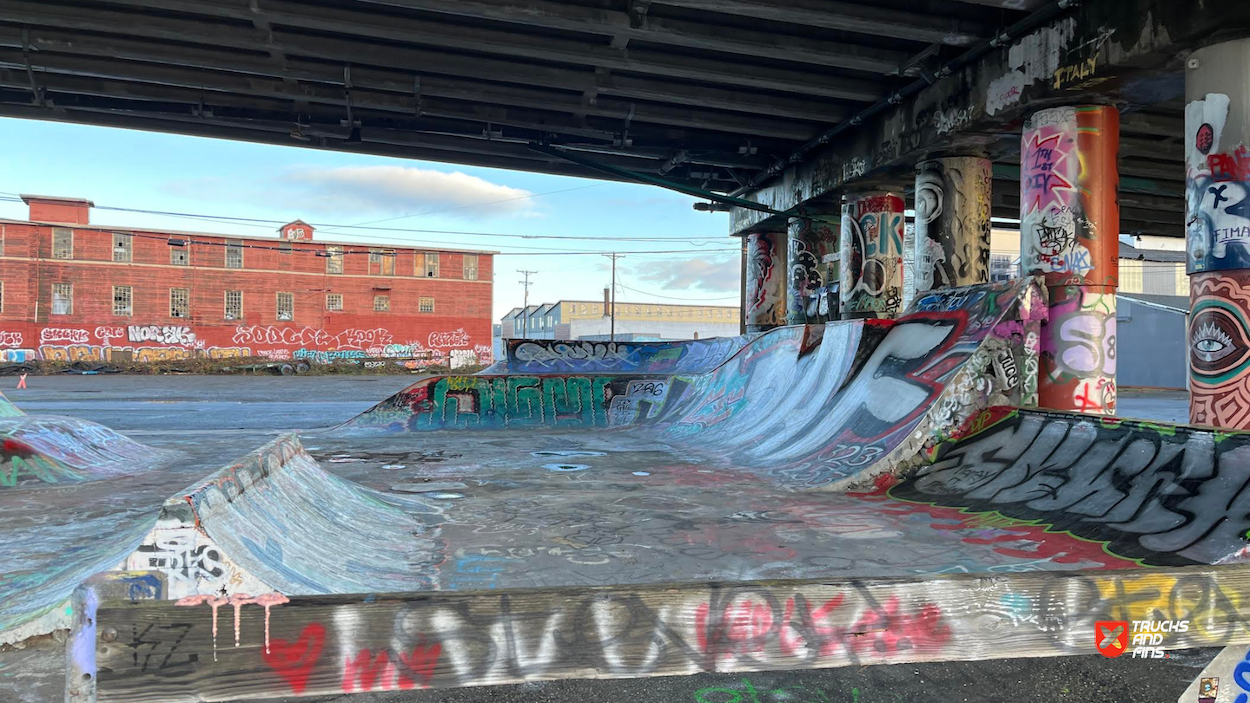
[0, 375, 1216, 703]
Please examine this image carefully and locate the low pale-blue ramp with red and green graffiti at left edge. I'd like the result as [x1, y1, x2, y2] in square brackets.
[0, 414, 173, 489]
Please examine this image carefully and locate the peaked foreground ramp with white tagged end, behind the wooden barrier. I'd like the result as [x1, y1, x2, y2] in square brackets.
[125, 435, 438, 598]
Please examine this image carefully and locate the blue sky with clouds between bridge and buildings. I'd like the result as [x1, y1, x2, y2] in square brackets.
[0, 118, 739, 320]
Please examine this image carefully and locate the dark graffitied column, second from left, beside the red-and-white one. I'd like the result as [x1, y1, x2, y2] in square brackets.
[785, 213, 840, 325]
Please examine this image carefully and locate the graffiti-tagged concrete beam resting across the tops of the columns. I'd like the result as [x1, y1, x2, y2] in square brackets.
[731, 0, 1250, 234]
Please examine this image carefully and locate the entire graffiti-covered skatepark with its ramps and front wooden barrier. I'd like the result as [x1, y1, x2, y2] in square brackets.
[7, 280, 1250, 702]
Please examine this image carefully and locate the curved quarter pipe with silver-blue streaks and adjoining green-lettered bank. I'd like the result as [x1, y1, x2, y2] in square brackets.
[341, 279, 1045, 488]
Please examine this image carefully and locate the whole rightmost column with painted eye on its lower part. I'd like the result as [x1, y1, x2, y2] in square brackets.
[1185, 39, 1250, 429]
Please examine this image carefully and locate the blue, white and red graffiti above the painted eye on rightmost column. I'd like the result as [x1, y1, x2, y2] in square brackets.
[1185, 93, 1250, 273]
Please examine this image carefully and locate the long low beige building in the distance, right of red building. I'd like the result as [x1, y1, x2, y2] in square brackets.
[500, 300, 740, 341]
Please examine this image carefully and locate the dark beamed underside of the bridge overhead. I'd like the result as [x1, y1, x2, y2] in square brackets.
[0, 0, 1230, 235]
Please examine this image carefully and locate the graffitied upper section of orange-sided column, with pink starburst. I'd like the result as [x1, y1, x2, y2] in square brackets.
[1020, 106, 1119, 286]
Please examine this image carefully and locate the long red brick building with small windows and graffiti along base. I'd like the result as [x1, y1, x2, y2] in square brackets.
[0, 195, 493, 367]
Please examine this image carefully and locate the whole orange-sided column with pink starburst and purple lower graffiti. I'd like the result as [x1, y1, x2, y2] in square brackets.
[1020, 105, 1120, 415]
